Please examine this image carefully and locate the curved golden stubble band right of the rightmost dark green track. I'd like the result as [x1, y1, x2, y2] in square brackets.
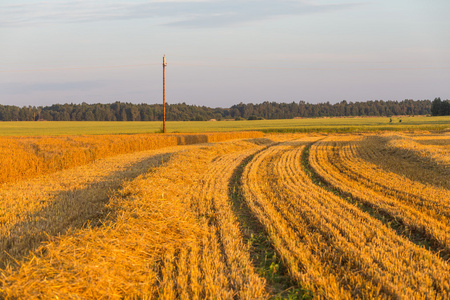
[310, 137, 450, 255]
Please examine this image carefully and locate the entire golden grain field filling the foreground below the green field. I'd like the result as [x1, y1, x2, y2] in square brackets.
[0, 131, 450, 299]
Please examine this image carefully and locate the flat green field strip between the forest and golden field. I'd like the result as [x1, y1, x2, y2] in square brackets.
[0, 116, 450, 136]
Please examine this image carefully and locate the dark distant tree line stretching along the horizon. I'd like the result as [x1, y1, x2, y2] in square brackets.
[0, 98, 450, 121]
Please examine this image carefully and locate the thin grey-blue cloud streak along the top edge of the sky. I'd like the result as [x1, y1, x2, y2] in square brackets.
[0, 0, 359, 27]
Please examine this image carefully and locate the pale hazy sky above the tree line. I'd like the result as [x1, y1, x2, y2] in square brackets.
[0, 0, 450, 107]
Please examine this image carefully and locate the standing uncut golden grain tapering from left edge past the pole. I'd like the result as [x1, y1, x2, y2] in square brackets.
[0, 131, 263, 184]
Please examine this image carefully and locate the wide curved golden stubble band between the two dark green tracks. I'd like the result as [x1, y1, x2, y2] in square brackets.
[243, 141, 450, 299]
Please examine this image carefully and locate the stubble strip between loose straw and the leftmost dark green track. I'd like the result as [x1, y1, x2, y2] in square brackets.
[159, 142, 265, 299]
